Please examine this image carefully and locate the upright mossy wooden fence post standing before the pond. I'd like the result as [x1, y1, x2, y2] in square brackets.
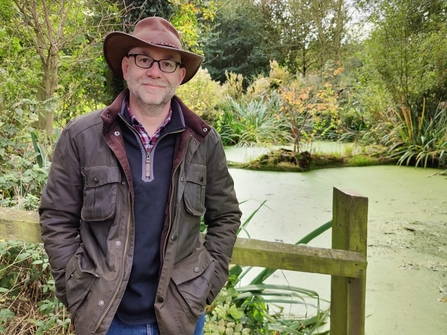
[330, 188, 368, 335]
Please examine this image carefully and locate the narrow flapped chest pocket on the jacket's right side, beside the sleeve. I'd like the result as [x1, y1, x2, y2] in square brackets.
[183, 164, 206, 216]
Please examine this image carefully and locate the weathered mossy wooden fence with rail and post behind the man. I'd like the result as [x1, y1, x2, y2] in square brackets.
[0, 188, 368, 335]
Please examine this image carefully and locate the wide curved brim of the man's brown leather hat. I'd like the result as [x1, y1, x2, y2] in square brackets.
[103, 31, 203, 84]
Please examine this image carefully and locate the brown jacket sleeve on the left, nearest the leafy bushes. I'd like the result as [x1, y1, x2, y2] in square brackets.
[39, 125, 83, 305]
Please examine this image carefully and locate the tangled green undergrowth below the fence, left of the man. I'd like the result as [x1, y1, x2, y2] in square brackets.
[0, 241, 73, 335]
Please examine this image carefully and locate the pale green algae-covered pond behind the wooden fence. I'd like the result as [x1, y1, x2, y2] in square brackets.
[226, 146, 447, 335]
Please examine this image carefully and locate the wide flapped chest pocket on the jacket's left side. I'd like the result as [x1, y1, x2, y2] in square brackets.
[81, 166, 121, 221]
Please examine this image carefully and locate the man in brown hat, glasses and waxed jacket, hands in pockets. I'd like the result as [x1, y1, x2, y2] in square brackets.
[39, 17, 241, 335]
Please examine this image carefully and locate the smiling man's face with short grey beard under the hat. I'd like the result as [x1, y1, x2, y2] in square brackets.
[121, 47, 186, 108]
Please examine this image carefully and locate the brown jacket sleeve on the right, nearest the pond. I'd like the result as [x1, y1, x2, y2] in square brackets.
[204, 132, 242, 304]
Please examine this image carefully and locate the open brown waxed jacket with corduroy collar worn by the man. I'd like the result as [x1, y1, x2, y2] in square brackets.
[39, 91, 241, 335]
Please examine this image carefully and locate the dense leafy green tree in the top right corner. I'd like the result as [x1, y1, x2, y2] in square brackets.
[361, 0, 447, 117]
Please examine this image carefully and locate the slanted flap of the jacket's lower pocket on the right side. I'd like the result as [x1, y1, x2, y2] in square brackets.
[172, 247, 214, 285]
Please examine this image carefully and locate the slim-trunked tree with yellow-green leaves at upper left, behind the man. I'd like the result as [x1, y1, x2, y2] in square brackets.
[9, 0, 117, 136]
